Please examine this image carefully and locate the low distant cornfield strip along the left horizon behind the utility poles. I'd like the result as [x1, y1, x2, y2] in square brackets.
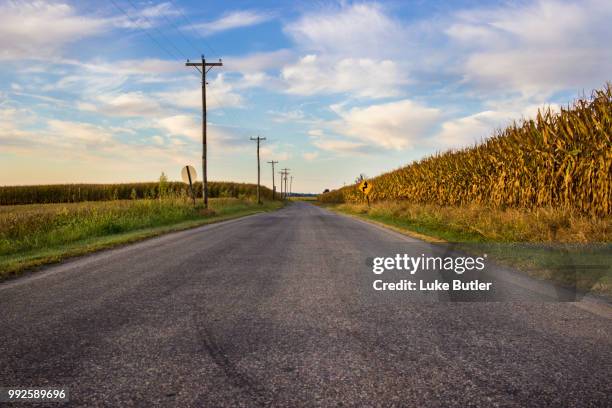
[0, 181, 272, 205]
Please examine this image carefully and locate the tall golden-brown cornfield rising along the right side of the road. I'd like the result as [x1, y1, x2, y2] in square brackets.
[319, 83, 612, 216]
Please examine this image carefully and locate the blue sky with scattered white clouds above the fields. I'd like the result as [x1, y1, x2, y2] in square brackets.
[0, 0, 612, 192]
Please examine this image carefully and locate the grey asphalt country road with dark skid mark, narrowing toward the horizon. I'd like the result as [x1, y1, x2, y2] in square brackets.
[0, 203, 612, 407]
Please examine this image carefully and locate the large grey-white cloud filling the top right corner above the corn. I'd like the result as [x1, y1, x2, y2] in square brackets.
[446, 0, 612, 97]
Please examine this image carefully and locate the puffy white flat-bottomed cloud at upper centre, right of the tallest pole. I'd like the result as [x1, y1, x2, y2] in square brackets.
[281, 54, 406, 98]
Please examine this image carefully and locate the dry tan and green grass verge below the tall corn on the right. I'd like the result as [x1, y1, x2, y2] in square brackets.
[320, 202, 612, 297]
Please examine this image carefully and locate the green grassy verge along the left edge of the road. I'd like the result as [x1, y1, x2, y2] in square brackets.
[0, 198, 283, 281]
